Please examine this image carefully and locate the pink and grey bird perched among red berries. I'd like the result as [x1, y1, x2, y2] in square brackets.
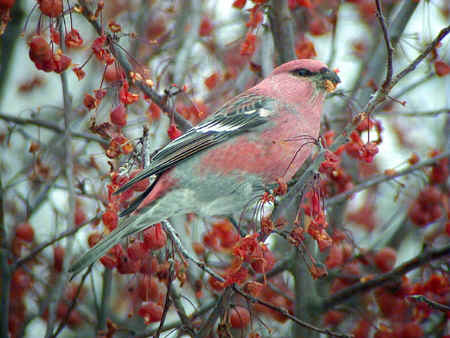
[71, 59, 340, 273]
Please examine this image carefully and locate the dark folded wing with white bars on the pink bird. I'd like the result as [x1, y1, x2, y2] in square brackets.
[115, 94, 274, 194]
